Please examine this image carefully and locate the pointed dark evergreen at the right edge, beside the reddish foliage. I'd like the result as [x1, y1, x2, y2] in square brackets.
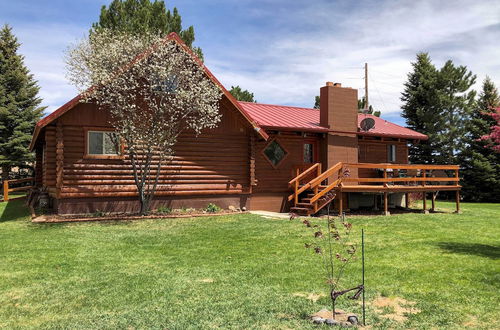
[460, 77, 500, 202]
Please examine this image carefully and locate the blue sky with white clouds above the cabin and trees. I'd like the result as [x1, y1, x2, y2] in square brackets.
[0, 0, 500, 124]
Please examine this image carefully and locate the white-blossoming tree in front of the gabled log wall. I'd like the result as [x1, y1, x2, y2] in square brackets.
[66, 29, 222, 214]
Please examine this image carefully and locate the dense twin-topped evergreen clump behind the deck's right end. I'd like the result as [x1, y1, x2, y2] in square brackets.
[401, 53, 476, 164]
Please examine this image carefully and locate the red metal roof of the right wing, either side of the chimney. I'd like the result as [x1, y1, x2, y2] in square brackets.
[240, 102, 427, 140]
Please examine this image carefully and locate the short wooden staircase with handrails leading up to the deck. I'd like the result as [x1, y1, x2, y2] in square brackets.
[288, 163, 343, 215]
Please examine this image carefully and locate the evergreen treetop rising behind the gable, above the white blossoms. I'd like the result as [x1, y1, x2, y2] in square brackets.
[91, 0, 203, 59]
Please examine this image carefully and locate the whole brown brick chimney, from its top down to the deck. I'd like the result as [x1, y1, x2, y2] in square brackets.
[320, 82, 358, 177]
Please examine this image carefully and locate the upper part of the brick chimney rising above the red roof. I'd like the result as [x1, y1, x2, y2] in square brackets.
[320, 82, 358, 132]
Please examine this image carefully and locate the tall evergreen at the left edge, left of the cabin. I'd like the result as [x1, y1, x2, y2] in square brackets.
[0, 25, 45, 180]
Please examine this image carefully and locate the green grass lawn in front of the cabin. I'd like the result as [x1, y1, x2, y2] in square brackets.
[0, 200, 500, 329]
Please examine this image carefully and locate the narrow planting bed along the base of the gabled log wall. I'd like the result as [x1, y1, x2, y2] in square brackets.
[31, 211, 248, 223]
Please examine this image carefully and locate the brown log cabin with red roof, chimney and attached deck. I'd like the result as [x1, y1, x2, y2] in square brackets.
[30, 33, 460, 215]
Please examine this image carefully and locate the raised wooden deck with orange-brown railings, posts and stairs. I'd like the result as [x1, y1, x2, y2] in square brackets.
[288, 163, 461, 215]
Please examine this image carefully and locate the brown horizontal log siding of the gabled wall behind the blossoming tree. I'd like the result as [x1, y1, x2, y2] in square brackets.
[56, 102, 250, 198]
